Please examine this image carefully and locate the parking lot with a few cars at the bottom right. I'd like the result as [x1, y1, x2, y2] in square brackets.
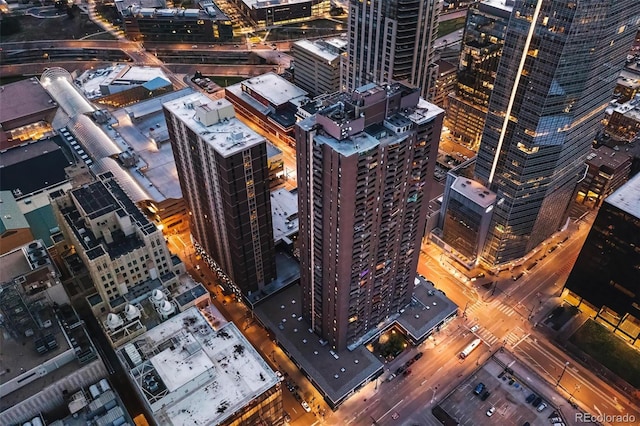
[440, 358, 565, 426]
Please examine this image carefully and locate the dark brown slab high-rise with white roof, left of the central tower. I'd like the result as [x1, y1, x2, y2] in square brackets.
[163, 93, 276, 295]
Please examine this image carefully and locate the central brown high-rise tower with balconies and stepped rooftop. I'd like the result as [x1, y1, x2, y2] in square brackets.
[296, 83, 444, 350]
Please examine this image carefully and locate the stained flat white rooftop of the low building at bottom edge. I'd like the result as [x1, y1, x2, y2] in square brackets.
[129, 307, 278, 426]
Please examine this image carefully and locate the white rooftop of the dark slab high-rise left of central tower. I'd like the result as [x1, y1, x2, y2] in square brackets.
[163, 93, 265, 157]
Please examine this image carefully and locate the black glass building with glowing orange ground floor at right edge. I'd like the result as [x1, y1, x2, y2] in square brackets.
[564, 174, 640, 346]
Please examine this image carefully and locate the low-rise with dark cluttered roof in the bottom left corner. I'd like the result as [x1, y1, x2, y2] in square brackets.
[0, 241, 107, 425]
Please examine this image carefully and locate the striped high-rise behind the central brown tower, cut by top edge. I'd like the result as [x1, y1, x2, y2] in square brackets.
[343, 0, 442, 99]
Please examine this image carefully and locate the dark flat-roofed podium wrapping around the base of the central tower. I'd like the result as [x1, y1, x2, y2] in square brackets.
[254, 276, 458, 410]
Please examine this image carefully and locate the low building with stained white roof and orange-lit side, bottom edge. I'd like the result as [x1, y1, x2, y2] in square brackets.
[117, 305, 284, 426]
